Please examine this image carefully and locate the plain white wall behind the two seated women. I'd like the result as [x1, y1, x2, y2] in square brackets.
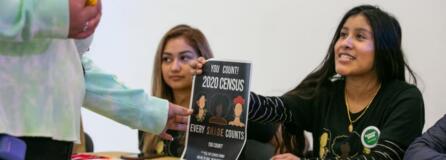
[83, 0, 446, 152]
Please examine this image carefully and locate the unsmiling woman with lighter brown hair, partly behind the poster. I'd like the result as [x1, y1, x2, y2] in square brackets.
[138, 24, 213, 157]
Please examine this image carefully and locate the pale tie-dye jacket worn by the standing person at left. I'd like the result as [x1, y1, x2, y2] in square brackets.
[0, 0, 168, 142]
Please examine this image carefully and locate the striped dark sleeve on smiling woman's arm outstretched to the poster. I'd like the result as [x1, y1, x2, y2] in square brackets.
[249, 92, 312, 131]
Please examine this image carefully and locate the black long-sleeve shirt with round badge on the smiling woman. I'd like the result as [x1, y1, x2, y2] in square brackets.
[249, 80, 424, 159]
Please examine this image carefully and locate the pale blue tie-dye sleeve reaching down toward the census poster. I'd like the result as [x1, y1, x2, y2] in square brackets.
[82, 56, 169, 134]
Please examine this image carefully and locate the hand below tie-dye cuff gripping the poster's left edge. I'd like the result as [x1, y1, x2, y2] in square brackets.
[159, 103, 192, 141]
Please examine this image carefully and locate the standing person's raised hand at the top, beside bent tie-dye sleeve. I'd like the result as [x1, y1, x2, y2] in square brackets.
[68, 0, 102, 39]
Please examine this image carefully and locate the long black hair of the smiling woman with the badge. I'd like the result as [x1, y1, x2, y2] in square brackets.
[288, 5, 417, 98]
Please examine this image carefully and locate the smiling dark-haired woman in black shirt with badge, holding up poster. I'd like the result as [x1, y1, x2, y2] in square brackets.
[193, 5, 424, 159]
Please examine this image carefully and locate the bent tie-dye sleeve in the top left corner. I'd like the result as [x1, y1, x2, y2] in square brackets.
[0, 0, 69, 42]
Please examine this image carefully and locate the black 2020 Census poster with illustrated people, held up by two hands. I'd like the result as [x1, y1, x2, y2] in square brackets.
[181, 60, 251, 160]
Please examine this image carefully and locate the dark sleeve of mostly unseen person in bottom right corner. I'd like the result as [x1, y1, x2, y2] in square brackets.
[404, 115, 446, 160]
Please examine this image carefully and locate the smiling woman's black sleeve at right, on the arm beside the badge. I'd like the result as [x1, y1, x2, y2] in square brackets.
[358, 87, 424, 159]
